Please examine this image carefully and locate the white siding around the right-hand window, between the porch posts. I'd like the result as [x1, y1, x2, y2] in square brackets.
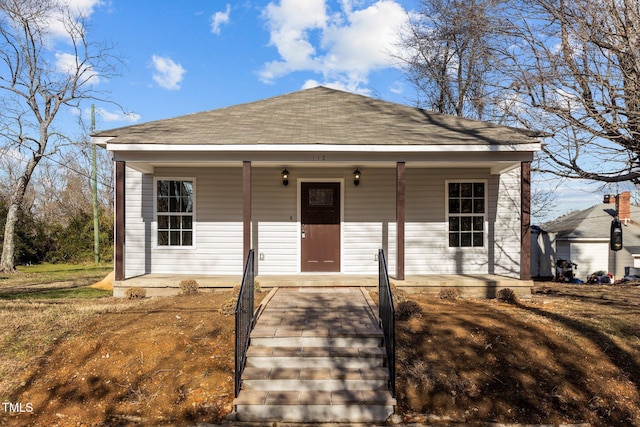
[405, 168, 520, 277]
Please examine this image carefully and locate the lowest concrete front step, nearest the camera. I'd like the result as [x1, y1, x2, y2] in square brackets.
[235, 390, 396, 423]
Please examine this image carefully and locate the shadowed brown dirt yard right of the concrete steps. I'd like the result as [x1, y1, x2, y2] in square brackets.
[396, 284, 640, 426]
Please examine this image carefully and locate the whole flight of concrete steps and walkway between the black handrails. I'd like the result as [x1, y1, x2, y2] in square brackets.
[234, 289, 396, 424]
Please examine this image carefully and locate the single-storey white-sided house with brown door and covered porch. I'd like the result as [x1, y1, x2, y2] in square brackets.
[92, 87, 542, 296]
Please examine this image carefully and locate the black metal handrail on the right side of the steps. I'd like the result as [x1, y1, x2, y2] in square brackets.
[378, 249, 396, 397]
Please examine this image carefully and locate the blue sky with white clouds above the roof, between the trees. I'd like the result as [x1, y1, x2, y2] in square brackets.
[80, 0, 418, 129]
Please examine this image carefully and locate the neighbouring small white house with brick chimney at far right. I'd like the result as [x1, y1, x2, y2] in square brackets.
[531, 191, 640, 282]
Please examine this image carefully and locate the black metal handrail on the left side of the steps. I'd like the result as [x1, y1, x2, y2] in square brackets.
[235, 249, 255, 397]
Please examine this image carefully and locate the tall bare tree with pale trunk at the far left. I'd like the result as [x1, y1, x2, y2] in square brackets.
[0, 0, 117, 272]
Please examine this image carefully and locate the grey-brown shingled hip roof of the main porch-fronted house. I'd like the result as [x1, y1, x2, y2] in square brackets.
[92, 87, 544, 145]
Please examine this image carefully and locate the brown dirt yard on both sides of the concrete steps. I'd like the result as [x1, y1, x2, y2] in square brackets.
[0, 284, 640, 426]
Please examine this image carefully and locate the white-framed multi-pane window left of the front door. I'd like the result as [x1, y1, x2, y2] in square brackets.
[156, 180, 194, 246]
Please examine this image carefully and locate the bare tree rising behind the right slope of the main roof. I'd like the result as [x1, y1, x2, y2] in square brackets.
[400, 0, 503, 119]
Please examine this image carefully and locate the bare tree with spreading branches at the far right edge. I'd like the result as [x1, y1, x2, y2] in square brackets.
[504, 0, 640, 184]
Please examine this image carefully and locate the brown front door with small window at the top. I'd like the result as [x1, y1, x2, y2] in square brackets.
[300, 182, 340, 272]
